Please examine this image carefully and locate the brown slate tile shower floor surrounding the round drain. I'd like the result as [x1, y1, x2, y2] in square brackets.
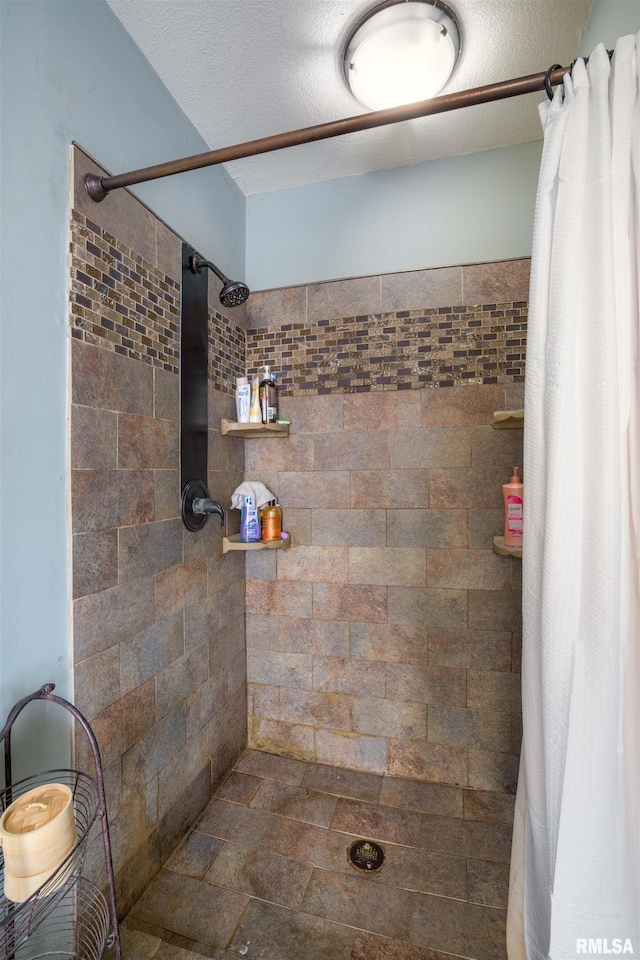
[122, 750, 513, 960]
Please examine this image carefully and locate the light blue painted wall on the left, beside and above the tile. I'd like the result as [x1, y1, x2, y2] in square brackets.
[0, 0, 245, 765]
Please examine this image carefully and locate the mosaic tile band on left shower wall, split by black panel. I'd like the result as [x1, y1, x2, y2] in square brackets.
[70, 210, 246, 395]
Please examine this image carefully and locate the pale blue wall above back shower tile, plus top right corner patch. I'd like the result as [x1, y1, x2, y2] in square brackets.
[247, 0, 640, 290]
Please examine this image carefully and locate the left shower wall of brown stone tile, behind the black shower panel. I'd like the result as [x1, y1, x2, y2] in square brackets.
[70, 149, 247, 914]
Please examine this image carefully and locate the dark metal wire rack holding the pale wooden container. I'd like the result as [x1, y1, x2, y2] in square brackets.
[0, 683, 122, 960]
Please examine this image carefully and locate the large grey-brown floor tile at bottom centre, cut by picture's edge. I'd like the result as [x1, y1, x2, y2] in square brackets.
[229, 900, 354, 960]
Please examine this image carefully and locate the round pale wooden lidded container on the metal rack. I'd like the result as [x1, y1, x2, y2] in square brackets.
[0, 783, 77, 903]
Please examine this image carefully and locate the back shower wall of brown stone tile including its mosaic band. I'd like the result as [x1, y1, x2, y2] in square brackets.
[245, 260, 529, 792]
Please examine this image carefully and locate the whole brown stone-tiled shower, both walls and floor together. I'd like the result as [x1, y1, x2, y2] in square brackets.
[70, 149, 529, 960]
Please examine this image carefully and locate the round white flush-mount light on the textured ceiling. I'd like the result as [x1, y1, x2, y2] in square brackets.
[343, 0, 460, 110]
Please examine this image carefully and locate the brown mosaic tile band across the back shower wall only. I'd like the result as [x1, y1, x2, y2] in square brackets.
[247, 300, 527, 396]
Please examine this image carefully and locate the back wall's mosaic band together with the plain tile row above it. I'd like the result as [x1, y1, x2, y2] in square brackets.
[247, 260, 529, 396]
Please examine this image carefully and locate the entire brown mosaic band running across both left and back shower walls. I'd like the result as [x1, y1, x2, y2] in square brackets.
[70, 210, 527, 396]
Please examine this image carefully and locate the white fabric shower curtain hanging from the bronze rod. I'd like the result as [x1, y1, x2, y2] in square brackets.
[507, 35, 640, 960]
